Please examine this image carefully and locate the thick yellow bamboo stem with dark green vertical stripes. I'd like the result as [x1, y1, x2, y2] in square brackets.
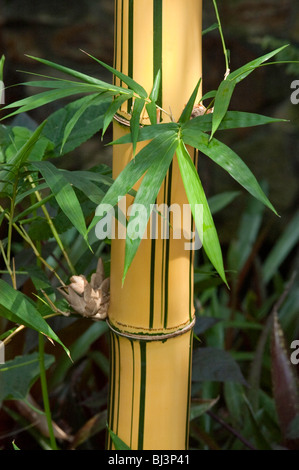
[107, 0, 202, 450]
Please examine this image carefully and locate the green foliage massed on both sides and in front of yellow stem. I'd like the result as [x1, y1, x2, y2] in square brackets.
[0, 2, 299, 449]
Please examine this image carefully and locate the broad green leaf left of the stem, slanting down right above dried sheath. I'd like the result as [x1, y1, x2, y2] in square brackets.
[32, 161, 86, 236]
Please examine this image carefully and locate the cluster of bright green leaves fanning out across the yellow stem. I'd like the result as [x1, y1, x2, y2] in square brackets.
[1, 46, 286, 283]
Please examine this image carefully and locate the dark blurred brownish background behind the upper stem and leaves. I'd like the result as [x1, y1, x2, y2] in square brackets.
[0, 0, 299, 242]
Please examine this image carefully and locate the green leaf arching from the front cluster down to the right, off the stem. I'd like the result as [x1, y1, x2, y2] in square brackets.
[182, 129, 277, 215]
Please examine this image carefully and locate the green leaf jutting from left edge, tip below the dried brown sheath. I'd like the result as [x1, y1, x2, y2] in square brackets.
[0, 279, 69, 355]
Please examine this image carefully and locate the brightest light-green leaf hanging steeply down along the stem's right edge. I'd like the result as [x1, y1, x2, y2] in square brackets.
[177, 141, 227, 284]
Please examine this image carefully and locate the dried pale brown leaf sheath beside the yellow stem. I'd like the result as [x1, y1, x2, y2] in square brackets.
[58, 258, 110, 320]
